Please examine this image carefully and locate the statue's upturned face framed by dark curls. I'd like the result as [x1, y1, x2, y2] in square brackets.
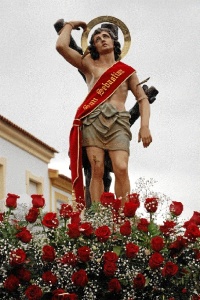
[94, 31, 114, 54]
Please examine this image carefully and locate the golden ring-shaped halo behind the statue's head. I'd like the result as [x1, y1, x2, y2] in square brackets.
[81, 16, 131, 60]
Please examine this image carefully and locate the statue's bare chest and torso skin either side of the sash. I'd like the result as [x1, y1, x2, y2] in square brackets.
[85, 60, 128, 111]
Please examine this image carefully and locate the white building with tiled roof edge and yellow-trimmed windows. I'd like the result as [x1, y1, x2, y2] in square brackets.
[0, 115, 72, 211]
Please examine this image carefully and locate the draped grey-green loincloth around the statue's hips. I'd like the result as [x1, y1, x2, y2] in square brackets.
[82, 102, 132, 153]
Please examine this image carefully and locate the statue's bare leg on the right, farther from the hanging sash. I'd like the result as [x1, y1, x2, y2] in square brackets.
[109, 150, 130, 204]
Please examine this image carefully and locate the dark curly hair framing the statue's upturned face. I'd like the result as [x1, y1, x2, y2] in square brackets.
[88, 28, 121, 60]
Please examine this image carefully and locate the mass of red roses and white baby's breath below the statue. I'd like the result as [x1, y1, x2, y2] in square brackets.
[0, 179, 200, 300]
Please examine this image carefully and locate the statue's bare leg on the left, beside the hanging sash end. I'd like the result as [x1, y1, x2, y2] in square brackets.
[86, 147, 105, 202]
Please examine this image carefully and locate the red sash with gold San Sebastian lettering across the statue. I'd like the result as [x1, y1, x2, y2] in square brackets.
[69, 61, 135, 203]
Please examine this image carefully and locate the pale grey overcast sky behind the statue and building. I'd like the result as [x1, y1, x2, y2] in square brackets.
[0, 0, 200, 219]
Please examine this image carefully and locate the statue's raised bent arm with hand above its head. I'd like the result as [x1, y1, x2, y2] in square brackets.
[56, 21, 87, 73]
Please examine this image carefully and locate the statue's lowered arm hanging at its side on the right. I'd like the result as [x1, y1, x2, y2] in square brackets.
[128, 73, 152, 148]
